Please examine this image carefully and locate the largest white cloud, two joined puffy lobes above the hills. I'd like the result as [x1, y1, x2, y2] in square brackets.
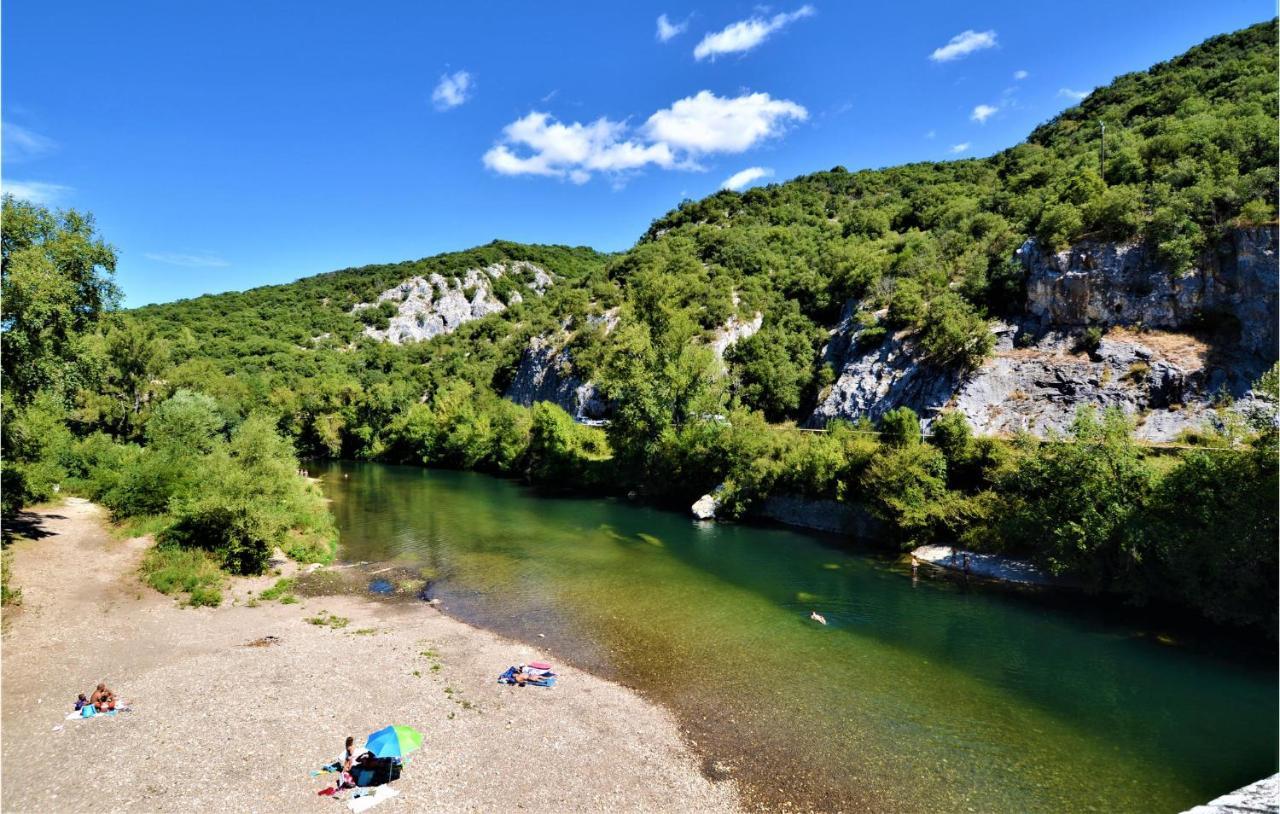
[483, 91, 809, 184]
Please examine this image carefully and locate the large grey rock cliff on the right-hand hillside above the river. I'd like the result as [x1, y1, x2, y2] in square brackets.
[808, 229, 1280, 440]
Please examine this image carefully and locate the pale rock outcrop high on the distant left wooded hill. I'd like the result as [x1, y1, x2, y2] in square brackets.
[352, 260, 553, 344]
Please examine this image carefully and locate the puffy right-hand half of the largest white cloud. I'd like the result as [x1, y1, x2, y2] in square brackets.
[645, 91, 809, 152]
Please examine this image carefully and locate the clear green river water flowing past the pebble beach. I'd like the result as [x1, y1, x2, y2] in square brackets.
[316, 463, 1277, 813]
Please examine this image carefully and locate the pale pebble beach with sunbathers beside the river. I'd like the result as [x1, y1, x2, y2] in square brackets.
[0, 500, 739, 814]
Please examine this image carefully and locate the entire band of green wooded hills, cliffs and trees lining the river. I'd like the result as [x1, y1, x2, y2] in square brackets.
[0, 20, 1280, 629]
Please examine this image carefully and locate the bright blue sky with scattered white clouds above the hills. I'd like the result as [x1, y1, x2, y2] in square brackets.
[0, 0, 1274, 306]
